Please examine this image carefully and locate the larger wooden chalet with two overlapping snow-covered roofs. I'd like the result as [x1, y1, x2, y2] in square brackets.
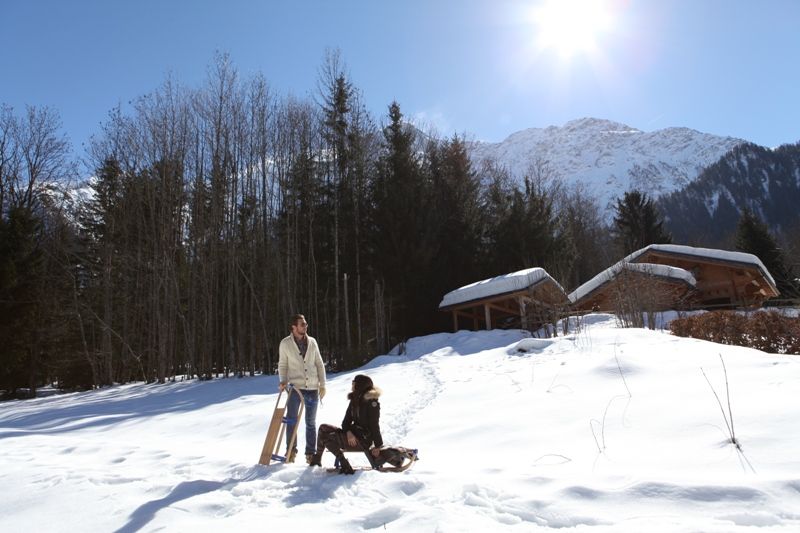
[570, 244, 779, 311]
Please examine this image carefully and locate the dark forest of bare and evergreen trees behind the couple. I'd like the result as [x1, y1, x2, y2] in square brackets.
[0, 51, 796, 395]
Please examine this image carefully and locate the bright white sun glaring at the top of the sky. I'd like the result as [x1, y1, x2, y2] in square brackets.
[531, 0, 613, 58]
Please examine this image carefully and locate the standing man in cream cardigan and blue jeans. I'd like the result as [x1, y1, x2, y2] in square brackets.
[278, 315, 325, 463]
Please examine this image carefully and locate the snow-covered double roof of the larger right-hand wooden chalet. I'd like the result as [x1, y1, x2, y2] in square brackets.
[569, 244, 775, 303]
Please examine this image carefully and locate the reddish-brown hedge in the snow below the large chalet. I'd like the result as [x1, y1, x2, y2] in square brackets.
[669, 311, 800, 354]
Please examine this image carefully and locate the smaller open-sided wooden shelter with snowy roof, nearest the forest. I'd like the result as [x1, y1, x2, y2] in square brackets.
[439, 268, 569, 331]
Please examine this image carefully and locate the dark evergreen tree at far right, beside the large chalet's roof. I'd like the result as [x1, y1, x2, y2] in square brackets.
[736, 209, 800, 299]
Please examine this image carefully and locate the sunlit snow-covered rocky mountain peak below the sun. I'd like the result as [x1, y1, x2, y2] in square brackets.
[473, 118, 745, 213]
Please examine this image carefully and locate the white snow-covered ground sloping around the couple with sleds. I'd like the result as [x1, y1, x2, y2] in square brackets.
[0, 315, 800, 532]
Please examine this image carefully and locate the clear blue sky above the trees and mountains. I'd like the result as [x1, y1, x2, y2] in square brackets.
[0, 0, 800, 153]
